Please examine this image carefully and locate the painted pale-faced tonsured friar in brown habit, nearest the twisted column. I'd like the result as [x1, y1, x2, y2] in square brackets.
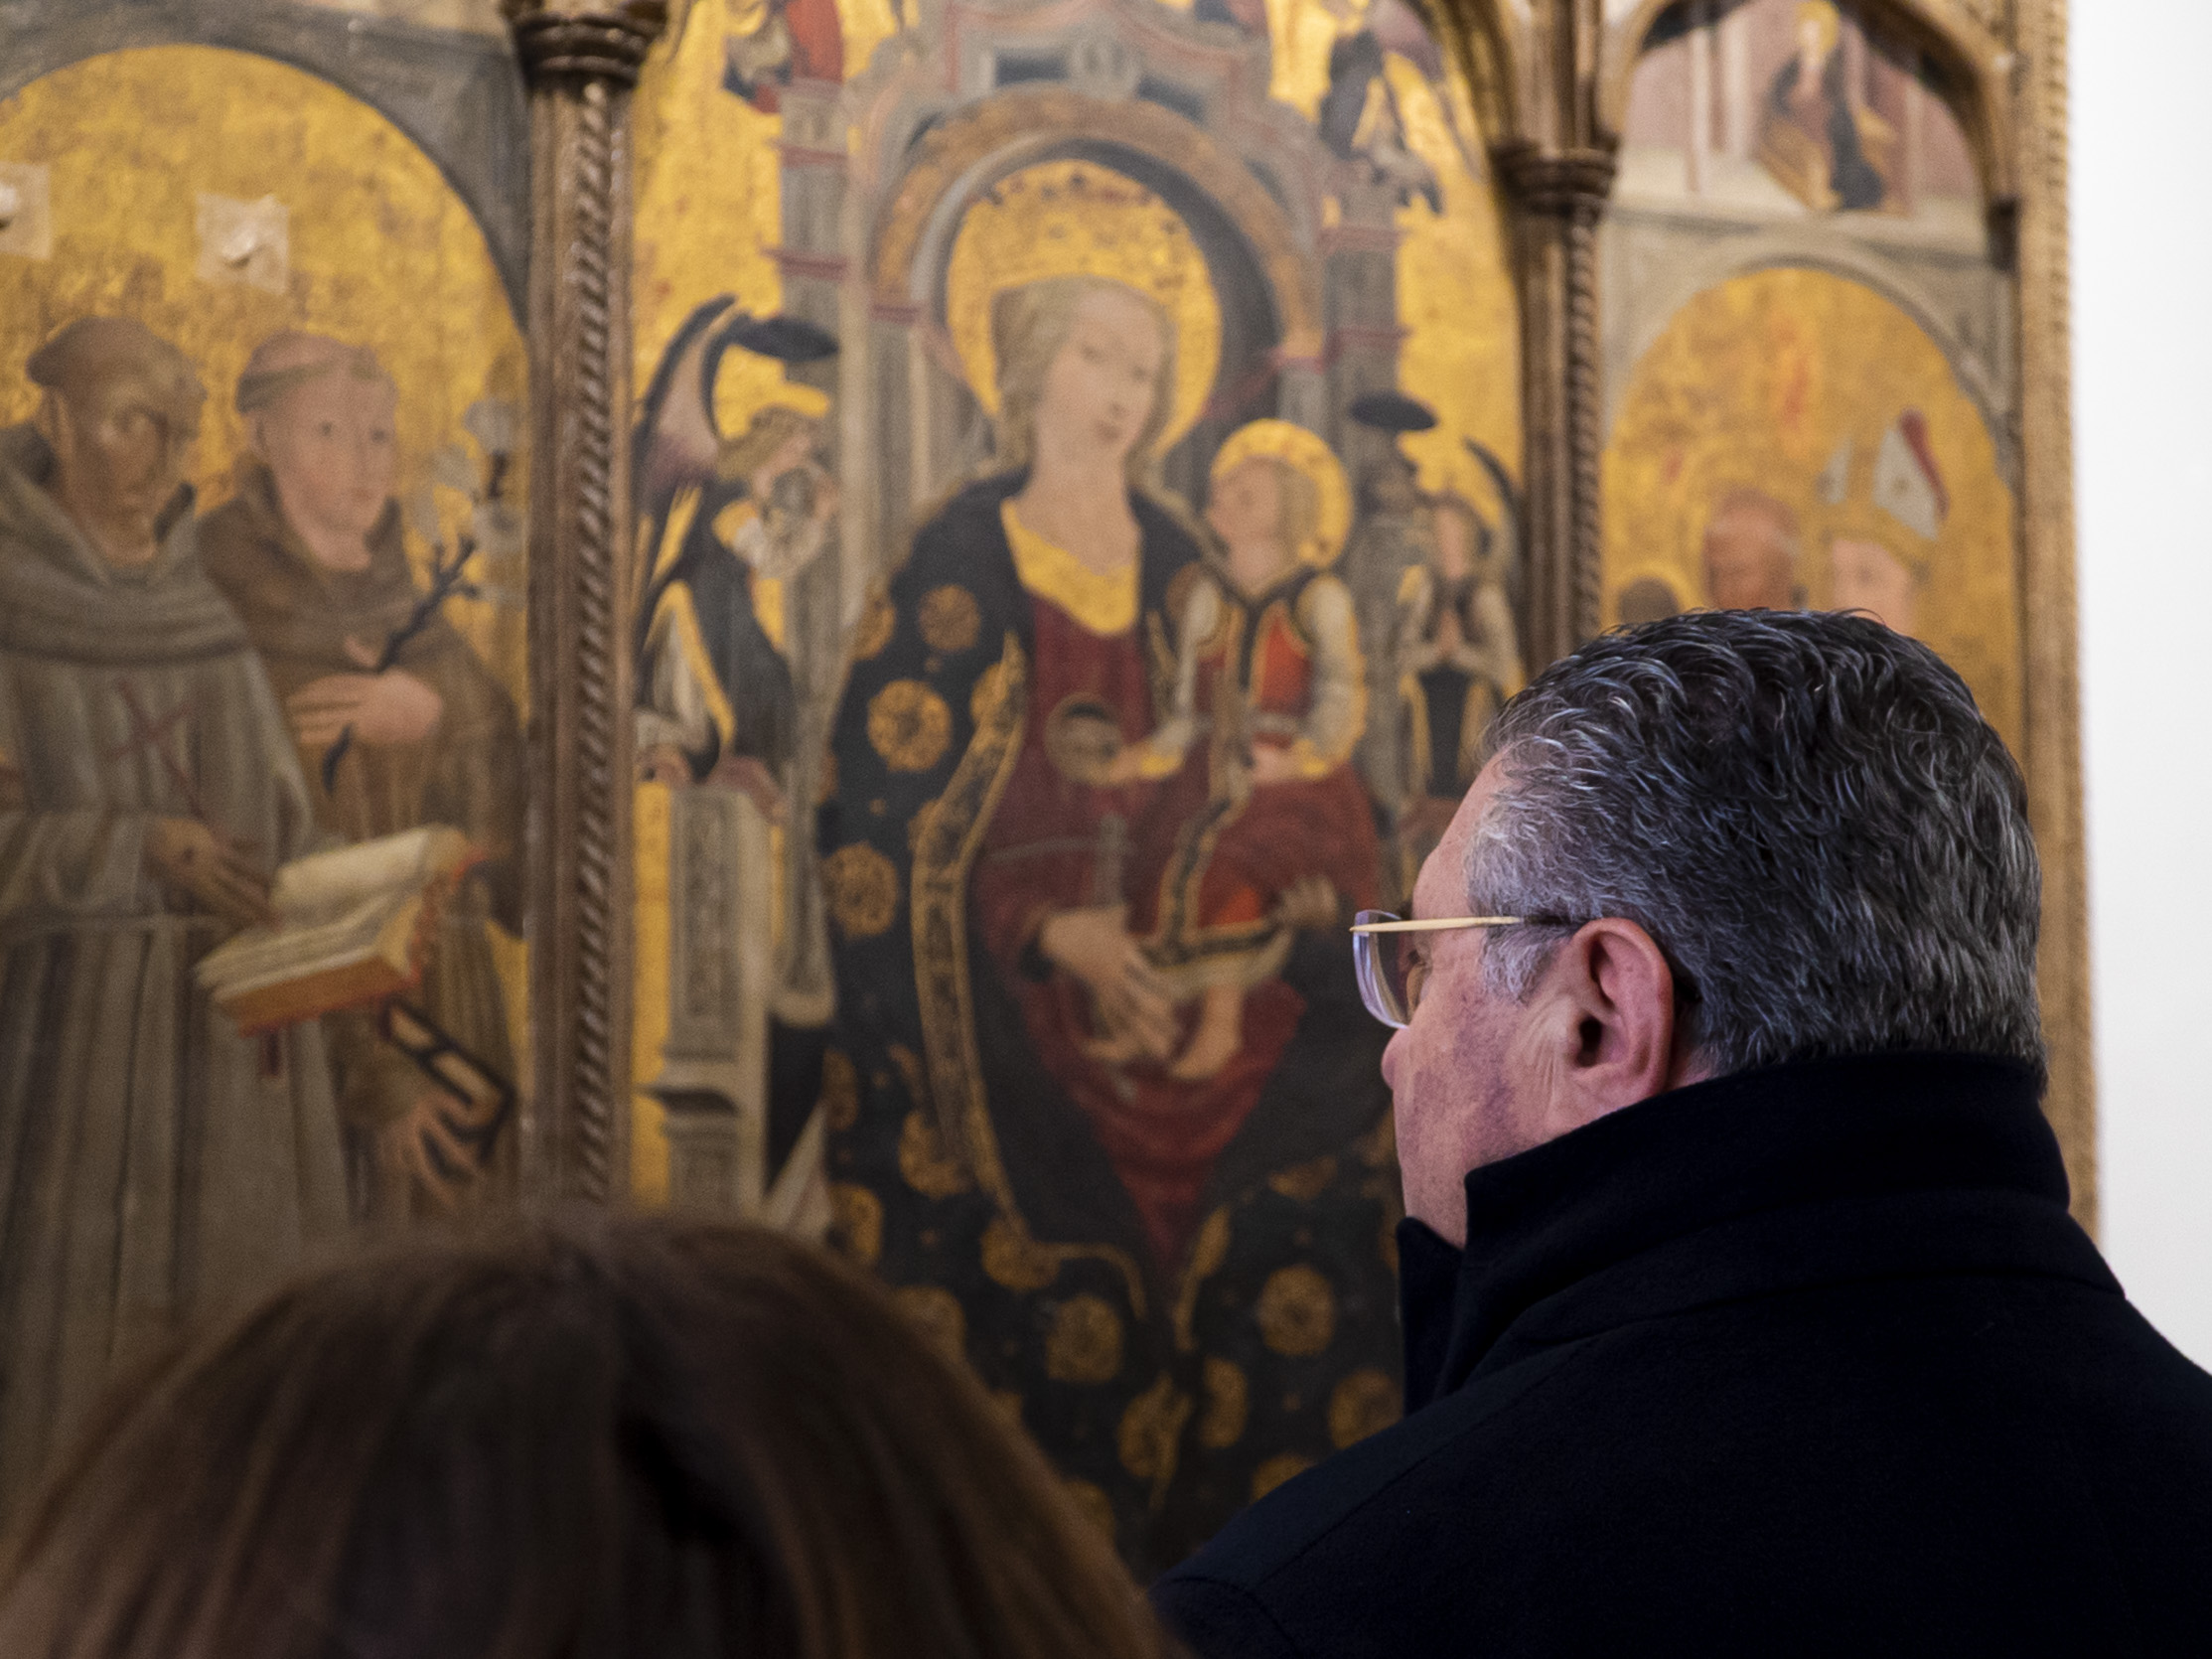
[199, 332, 526, 1219]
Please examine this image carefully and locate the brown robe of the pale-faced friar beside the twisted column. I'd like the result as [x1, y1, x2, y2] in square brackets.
[199, 462, 526, 1214]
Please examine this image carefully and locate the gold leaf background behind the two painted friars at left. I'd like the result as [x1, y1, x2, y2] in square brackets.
[0, 47, 528, 1055]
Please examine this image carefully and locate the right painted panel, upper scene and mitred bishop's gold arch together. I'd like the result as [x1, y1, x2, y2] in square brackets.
[1601, 0, 2021, 745]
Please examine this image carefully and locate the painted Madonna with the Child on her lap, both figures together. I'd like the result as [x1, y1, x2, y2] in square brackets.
[820, 274, 1398, 1560]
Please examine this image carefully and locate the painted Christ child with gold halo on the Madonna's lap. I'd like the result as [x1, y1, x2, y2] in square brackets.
[1117, 420, 1378, 1080]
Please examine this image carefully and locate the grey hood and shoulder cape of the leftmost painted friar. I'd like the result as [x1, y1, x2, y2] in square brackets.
[0, 427, 245, 664]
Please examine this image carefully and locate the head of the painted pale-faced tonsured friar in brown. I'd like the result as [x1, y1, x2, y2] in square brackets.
[239, 332, 398, 568]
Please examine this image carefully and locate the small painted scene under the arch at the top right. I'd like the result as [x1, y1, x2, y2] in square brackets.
[1619, 0, 1982, 241]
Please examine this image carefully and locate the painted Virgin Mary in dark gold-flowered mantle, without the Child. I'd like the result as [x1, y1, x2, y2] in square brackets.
[820, 274, 1398, 1571]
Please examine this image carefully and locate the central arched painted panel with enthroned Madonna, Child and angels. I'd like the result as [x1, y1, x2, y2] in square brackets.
[635, 0, 1524, 1571]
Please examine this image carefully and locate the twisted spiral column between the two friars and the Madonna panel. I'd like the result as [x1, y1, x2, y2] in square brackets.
[507, 0, 665, 1203]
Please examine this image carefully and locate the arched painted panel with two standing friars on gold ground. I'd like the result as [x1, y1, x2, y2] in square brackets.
[0, 47, 526, 1509]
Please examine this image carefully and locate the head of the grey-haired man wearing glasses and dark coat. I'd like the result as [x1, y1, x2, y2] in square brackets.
[1385, 611, 2044, 1241]
